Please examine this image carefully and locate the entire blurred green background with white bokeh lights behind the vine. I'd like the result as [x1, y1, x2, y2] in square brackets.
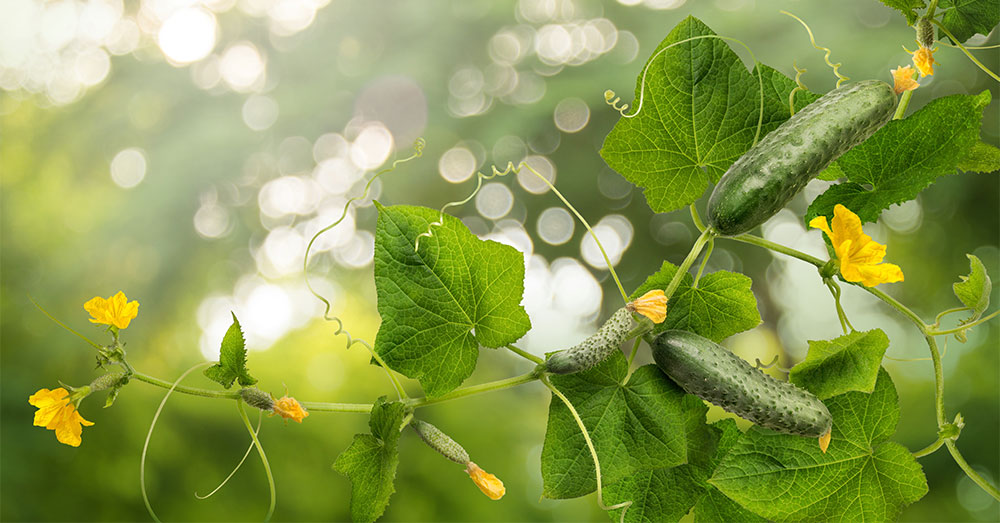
[0, 0, 1000, 521]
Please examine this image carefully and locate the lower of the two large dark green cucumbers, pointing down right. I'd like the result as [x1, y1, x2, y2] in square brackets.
[653, 330, 833, 437]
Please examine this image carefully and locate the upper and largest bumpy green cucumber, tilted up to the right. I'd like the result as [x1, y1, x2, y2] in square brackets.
[708, 80, 896, 236]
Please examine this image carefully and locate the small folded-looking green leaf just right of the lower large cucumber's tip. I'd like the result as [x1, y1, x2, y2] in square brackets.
[788, 329, 889, 400]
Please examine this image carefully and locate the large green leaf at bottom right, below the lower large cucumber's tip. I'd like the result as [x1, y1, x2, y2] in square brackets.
[709, 369, 927, 521]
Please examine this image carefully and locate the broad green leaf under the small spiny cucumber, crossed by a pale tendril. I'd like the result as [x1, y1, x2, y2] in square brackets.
[542, 351, 688, 499]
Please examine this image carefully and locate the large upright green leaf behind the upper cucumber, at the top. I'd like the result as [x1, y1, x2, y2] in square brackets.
[601, 17, 814, 212]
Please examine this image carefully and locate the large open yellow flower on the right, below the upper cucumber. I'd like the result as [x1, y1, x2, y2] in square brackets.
[809, 203, 903, 287]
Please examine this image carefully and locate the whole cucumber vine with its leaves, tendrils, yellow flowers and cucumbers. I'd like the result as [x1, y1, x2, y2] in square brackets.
[29, 0, 1000, 522]
